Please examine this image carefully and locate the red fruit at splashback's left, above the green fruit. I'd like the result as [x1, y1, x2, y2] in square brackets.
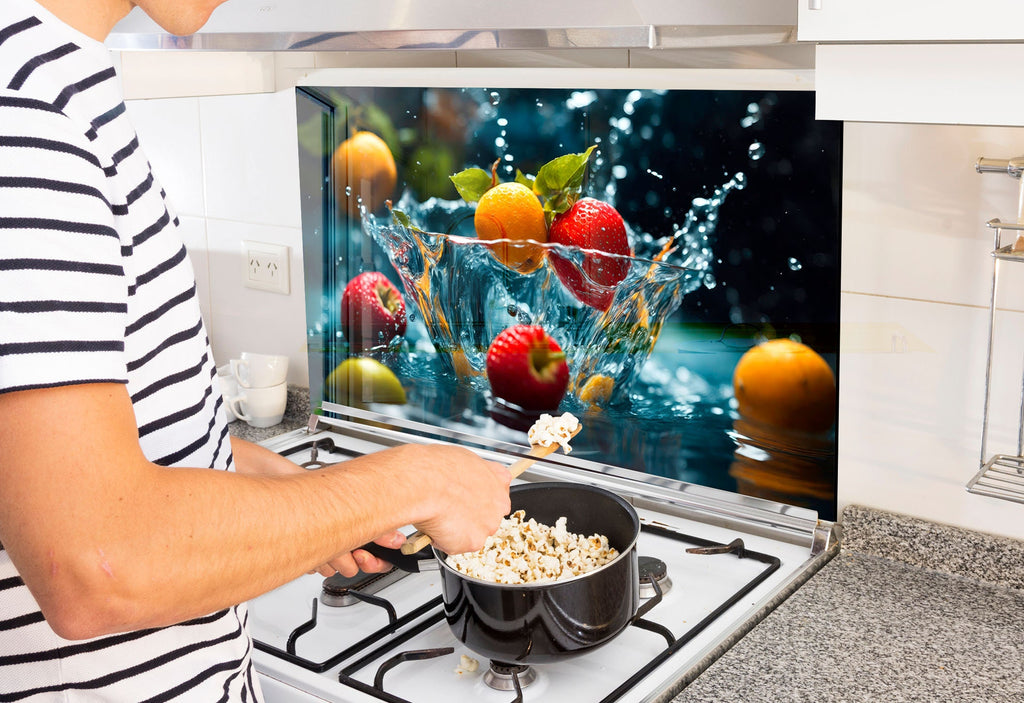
[341, 271, 406, 351]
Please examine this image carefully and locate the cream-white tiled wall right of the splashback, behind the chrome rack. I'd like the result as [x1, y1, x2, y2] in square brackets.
[839, 123, 1024, 538]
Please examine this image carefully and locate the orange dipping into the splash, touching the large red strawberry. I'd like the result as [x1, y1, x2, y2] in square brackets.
[473, 183, 548, 273]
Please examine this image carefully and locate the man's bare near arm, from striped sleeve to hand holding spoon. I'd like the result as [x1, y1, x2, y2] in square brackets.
[0, 384, 509, 639]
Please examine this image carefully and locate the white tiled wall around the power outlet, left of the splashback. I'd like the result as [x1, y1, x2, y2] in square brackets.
[127, 90, 309, 386]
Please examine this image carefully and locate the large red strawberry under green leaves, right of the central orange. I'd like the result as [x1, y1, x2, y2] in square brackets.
[548, 197, 632, 310]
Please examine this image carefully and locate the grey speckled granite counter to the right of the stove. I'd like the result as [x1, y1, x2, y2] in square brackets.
[673, 507, 1024, 703]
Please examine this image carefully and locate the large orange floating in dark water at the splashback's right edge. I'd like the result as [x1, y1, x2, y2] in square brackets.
[732, 339, 836, 432]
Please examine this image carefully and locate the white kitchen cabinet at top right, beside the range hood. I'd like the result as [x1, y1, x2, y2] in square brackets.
[797, 0, 1024, 126]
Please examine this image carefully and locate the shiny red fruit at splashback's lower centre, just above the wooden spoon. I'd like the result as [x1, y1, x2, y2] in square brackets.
[486, 324, 569, 410]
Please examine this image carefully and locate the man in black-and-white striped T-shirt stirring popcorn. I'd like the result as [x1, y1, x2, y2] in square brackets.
[0, 0, 510, 703]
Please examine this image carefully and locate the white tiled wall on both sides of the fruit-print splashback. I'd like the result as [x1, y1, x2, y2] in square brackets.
[121, 57, 1024, 538]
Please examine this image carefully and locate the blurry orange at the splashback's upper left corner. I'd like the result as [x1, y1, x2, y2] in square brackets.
[334, 132, 398, 217]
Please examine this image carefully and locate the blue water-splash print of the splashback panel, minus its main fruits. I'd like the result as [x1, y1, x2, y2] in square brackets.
[296, 78, 842, 519]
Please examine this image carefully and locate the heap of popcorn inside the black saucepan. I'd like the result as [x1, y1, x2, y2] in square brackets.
[445, 511, 618, 583]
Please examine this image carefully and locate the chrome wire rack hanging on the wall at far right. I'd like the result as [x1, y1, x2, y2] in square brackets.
[967, 157, 1024, 503]
